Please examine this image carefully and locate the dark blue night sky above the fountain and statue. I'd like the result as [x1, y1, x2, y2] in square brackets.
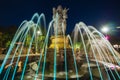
[0, 0, 120, 32]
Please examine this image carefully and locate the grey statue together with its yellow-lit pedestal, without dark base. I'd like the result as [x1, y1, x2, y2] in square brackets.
[49, 6, 70, 50]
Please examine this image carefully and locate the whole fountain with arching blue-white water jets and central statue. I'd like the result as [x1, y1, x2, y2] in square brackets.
[0, 6, 120, 80]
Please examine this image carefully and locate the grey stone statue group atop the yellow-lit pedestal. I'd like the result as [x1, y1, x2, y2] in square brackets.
[53, 6, 68, 35]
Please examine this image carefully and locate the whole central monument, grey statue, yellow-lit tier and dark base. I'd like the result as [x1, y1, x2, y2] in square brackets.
[47, 6, 78, 72]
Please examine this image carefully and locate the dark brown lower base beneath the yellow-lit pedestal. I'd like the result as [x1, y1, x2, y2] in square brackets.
[46, 48, 75, 72]
